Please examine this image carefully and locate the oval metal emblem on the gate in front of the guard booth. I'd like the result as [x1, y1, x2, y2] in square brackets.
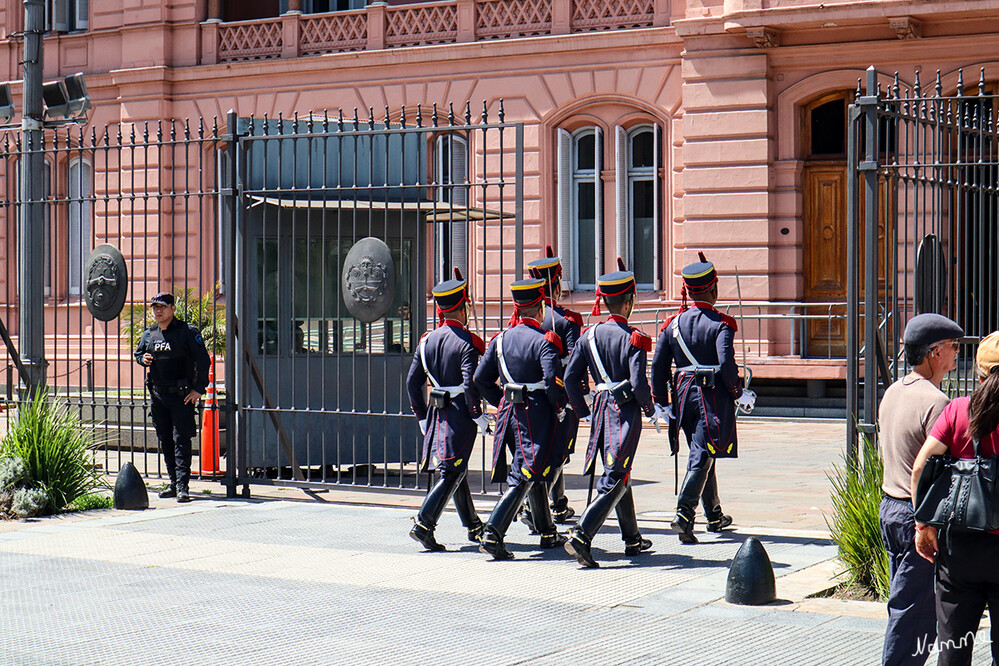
[341, 236, 395, 323]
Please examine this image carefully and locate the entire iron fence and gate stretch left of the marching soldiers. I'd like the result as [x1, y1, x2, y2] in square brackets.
[0, 101, 524, 493]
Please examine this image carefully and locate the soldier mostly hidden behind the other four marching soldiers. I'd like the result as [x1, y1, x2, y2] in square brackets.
[527, 245, 583, 524]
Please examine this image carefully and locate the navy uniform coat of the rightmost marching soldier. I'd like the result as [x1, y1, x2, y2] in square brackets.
[652, 301, 742, 458]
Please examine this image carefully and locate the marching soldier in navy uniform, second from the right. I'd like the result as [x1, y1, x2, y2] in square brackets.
[565, 271, 655, 568]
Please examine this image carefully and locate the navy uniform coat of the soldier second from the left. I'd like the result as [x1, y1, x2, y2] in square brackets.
[475, 319, 565, 485]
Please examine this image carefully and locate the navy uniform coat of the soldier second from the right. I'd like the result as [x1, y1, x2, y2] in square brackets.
[565, 315, 652, 491]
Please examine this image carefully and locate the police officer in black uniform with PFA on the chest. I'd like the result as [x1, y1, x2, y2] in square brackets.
[135, 291, 211, 502]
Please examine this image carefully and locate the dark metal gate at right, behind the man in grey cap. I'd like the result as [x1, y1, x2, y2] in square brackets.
[847, 67, 999, 461]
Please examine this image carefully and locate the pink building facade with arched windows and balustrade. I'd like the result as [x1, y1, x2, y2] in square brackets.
[0, 0, 999, 379]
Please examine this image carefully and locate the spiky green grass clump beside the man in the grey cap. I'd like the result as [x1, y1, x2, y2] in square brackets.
[826, 437, 889, 599]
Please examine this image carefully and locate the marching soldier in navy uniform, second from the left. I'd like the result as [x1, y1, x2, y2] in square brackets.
[475, 279, 565, 560]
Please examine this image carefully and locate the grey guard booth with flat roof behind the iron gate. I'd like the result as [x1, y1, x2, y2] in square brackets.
[227, 109, 520, 486]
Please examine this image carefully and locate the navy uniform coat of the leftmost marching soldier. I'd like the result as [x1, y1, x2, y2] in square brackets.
[406, 319, 485, 472]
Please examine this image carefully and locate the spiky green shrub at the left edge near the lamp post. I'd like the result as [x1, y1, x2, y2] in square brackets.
[0, 390, 107, 511]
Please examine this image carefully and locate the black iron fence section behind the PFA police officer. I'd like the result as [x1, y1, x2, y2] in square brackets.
[0, 120, 225, 476]
